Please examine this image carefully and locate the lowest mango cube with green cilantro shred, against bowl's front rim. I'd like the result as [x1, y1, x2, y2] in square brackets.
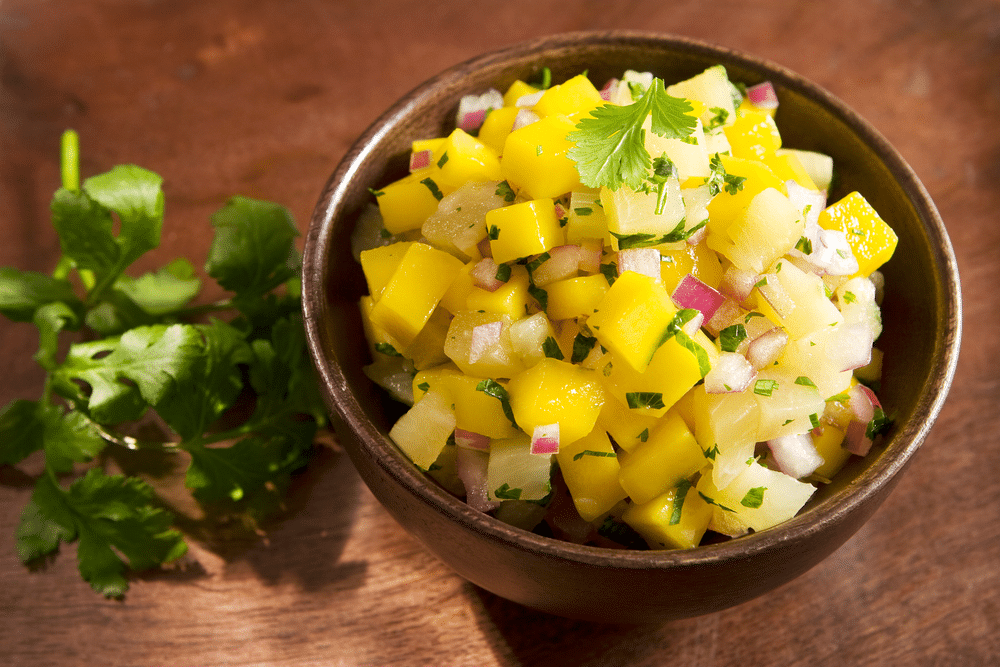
[622, 483, 712, 549]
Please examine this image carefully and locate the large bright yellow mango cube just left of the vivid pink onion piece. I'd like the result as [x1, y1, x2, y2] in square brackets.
[587, 271, 677, 373]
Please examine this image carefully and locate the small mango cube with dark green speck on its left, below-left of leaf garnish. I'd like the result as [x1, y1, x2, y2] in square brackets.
[486, 199, 564, 264]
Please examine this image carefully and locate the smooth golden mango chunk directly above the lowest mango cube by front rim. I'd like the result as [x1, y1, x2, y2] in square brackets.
[618, 411, 707, 504]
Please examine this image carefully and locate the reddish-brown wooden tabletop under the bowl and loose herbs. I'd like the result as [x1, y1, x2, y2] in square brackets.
[0, 0, 1000, 667]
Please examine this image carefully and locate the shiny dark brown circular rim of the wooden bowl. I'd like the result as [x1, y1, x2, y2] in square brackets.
[303, 31, 962, 570]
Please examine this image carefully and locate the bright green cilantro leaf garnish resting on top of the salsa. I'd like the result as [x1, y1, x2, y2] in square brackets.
[566, 78, 696, 190]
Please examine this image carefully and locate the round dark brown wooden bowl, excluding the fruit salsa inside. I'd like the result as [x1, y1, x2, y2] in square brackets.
[303, 32, 961, 623]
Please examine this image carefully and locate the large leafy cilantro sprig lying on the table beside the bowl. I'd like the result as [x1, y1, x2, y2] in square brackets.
[0, 132, 325, 597]
